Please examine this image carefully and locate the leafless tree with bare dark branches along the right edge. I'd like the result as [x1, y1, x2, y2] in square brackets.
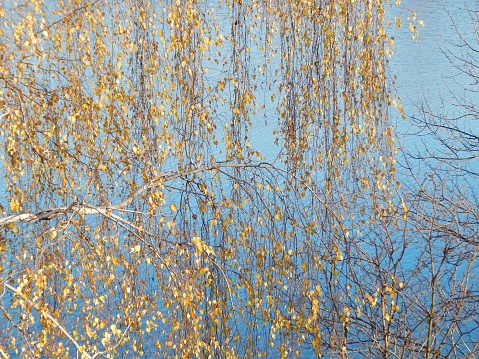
[394, 3, 479, 358]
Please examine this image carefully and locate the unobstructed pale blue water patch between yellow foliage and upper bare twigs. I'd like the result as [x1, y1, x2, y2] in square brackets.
[390, 0, 478, 160]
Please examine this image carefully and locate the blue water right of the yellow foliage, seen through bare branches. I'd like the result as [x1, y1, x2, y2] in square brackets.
[390, 0, 479, 357]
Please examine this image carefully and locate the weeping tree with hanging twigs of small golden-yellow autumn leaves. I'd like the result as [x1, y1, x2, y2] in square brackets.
[0, 0, 464, 358]
